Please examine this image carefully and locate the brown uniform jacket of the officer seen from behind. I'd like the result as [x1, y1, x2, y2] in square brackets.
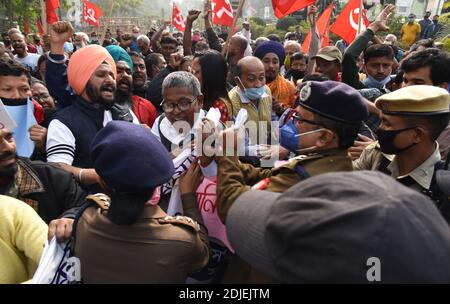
[75, 194, 209, 284]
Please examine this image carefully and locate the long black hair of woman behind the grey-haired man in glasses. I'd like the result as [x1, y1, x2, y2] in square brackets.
[196, 50, 229, 110]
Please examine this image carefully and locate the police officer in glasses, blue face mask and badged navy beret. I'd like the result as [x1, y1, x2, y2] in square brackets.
[217, 81, 368, 222]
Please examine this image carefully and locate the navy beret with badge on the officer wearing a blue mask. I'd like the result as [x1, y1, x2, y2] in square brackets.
[299, 81, 369, 125]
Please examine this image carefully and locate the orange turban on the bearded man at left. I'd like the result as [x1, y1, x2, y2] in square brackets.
[67, 45, 117, 95]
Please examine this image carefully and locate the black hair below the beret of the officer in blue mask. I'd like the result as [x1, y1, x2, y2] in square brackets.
[314, 113, 361, 149]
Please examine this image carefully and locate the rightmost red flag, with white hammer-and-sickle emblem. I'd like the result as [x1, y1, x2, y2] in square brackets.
[330, 0, 370, 44]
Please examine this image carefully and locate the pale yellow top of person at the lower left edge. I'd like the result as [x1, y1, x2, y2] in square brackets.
[0, 195, 48, 284]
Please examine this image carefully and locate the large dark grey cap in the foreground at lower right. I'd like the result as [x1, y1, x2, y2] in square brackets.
[226, 171, 450, 284]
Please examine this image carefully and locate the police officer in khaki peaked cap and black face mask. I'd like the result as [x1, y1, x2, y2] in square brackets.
[353, 85, 450, 221]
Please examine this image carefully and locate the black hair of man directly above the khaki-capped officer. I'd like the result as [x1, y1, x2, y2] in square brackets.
[400, 48, 450, 86]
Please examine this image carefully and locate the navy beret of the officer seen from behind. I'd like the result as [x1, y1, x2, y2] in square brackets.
[91, 121, 175, 192]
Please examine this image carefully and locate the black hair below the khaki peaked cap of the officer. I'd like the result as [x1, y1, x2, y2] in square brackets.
[401, 113, 450, 141]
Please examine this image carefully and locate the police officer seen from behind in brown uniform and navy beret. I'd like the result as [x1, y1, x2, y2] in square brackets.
[75, 121, 209, 283]
